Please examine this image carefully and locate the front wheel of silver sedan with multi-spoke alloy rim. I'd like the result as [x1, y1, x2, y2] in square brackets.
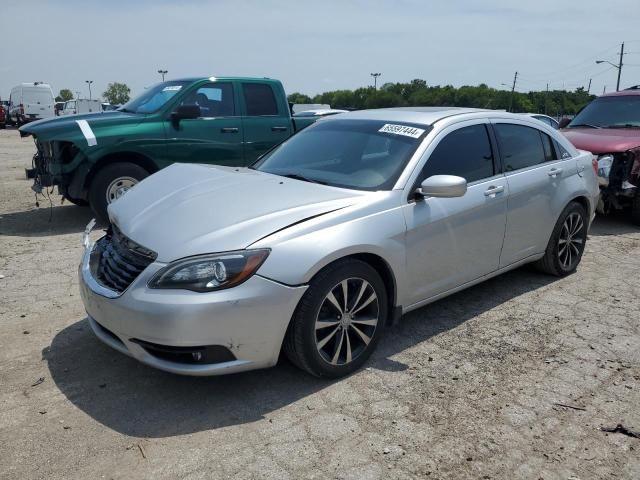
[283, 259, 388, 378]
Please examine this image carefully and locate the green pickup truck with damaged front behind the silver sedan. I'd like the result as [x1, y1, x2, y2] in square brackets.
[20, 77, 314, 220]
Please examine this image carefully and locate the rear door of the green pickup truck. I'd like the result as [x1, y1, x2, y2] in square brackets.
[241, 82, 293, 165]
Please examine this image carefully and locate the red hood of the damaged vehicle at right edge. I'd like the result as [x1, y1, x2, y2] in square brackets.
[561, 128, 640, 154]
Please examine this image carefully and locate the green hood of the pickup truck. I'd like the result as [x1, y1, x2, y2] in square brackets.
[20, 111, 145, 137]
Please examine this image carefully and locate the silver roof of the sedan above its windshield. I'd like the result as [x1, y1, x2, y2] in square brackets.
[322, 107, 522, 125]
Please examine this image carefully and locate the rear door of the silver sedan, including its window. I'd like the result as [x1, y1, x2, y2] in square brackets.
[493, 120, 578, 267]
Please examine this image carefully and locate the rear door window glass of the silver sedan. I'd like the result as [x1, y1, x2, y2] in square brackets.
[495, 123, 546, 172]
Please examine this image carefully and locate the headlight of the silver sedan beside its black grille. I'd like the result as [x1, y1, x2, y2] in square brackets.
[149, 250, 269, 292]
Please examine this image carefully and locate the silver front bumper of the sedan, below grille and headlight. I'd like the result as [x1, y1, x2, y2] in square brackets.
[79, 234, 307, 376]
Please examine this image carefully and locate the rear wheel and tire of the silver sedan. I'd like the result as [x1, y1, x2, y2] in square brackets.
[534, 202, 588, 277]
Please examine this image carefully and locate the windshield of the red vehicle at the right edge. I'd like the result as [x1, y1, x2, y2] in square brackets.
[568, 95, 640, 128]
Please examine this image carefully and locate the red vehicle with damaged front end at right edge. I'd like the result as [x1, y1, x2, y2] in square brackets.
[561, 85, 640, 225]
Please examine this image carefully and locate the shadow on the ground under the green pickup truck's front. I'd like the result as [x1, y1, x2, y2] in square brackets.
[0, 204, 101, 237]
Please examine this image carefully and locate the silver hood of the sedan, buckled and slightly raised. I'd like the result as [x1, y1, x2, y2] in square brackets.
[108, 164, 369, 262]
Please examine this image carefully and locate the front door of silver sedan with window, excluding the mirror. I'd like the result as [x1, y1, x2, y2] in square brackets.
[403, 120, 508, 304]
